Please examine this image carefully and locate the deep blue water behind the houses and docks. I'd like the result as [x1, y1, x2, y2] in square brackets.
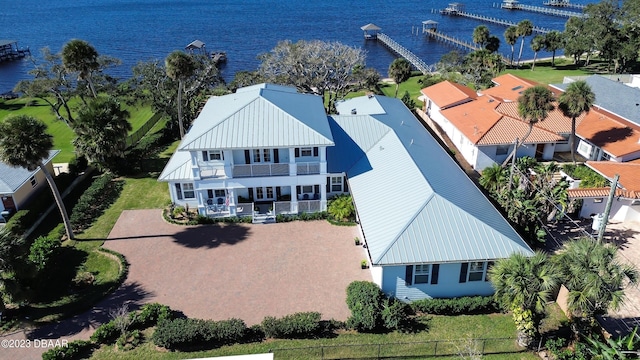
[0, 0, 587, 93]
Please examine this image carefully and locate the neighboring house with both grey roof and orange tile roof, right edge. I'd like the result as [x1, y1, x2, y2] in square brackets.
[551, 75, 640, 162]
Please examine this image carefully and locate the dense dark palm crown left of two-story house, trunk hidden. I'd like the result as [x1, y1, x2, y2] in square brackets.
[73, 97, 131, 170]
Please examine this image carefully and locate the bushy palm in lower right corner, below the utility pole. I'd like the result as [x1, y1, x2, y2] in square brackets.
[555, 238, 638, 323]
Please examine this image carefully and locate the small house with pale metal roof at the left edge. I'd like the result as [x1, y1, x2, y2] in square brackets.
[0, 150, 60, 217]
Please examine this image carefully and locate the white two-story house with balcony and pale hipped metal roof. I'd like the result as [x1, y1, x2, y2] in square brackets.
[159, 84, 346, 220]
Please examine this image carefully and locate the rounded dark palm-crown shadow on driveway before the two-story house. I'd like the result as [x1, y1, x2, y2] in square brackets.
[173, 224, 251, 249]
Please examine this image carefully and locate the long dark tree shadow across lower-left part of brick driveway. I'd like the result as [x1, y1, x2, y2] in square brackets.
[27, 282, 154, 339]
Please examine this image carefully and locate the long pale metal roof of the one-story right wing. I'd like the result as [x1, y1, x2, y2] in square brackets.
[327, 96, 531, 265]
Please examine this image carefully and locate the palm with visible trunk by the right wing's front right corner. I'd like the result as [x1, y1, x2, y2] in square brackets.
[489, 252, 560, 345]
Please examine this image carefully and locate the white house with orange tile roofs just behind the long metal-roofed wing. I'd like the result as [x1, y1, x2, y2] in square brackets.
[421, 74, 568, 171]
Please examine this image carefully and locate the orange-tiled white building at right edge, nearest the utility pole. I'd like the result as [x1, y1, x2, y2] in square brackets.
[568, 161, 640, 221]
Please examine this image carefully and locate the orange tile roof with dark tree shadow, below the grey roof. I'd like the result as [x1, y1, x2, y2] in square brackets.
[576, 109, 640, 157]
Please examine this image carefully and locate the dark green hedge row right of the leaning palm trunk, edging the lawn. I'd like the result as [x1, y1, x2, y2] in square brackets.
[70, 173, 124, 232]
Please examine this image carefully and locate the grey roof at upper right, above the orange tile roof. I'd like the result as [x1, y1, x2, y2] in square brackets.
[551, 75, 640, 125]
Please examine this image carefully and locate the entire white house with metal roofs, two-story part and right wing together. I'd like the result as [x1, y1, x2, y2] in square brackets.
[160, 84, 532, 300]
